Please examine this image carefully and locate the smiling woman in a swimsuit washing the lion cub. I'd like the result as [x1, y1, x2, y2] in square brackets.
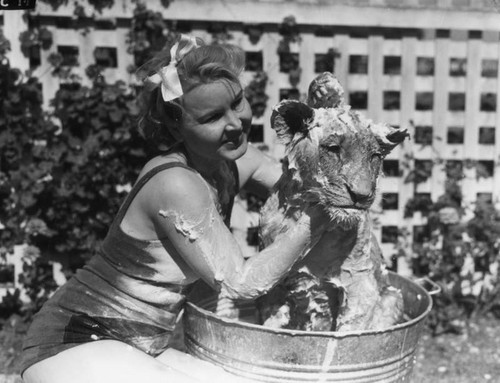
[23, 35, 328, 383]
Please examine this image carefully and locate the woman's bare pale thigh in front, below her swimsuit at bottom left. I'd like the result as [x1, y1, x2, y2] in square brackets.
[23, 340, 202, 383]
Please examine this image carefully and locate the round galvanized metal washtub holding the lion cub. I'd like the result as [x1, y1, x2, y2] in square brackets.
[184, 272, 437, 383]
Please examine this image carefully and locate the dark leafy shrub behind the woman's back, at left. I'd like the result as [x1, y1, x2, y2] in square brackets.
[0, 54, 147, 318]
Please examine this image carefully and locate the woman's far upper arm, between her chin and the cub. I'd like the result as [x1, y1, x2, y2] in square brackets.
[236, 144, 282, 198]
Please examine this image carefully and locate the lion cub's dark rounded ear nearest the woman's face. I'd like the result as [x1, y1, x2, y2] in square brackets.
[271, 100, 314, 145]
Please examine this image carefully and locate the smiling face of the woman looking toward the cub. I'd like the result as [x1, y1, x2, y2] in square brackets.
[180, 80, 252, 161]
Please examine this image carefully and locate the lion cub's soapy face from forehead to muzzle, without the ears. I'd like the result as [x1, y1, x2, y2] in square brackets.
[310, 108, 383, 209]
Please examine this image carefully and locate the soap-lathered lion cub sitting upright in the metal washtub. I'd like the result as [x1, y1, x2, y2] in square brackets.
[257, 73, 408, 331]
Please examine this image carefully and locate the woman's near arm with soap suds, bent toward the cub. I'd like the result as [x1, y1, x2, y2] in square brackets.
[147, 168, 327, 299]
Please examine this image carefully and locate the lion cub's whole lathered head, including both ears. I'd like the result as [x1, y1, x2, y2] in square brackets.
[272, 88, 406, 228]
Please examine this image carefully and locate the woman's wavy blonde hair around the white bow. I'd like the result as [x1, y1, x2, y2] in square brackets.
[138, 34, 245, 151]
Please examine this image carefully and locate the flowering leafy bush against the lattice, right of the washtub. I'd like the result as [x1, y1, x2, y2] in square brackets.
[403, 164, 500, 334]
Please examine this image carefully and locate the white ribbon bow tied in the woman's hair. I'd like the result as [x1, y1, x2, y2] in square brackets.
[146, 35, 198, 102]
